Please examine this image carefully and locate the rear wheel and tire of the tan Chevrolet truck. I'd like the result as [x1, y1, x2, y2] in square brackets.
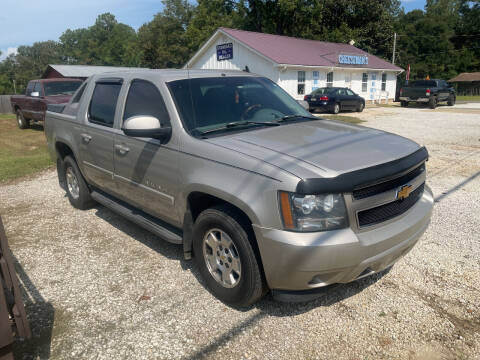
[63, 156, 95, 210]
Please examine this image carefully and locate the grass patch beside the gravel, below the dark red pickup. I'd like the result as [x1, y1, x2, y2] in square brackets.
[0, 114, 53, 182]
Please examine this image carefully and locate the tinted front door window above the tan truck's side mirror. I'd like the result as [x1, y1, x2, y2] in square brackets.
[123, 79, 170, 126]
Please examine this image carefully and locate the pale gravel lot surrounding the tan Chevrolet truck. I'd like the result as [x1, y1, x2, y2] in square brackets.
[0, 104, 480, 359]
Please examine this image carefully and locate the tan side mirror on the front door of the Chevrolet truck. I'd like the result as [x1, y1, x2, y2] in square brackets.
[122, 115, 172, 140]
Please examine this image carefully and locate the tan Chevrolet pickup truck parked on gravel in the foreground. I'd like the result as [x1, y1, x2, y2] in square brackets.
[45, 70, 433, 306]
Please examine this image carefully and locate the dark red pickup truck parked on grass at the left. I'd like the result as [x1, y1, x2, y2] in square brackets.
[10, 78, 83, 129]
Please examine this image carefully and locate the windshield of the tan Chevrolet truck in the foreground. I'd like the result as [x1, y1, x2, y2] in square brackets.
[168, 76, 312, 133]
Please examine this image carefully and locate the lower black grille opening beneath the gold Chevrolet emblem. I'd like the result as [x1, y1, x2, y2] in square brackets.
[358, 183, 425, 227]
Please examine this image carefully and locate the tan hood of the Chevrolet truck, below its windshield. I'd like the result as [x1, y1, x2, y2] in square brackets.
[207, 120, 420, 178]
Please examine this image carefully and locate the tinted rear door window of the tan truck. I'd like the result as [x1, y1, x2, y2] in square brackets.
[88, 82, 122, 127]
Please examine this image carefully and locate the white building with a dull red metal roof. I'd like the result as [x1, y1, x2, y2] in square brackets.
[185, 28, 403, 101]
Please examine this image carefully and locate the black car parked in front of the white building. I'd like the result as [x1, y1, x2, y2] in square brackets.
[303, 87, 365, 114]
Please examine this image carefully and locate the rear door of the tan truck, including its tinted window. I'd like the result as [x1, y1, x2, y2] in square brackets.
[80, 78, 123, 193]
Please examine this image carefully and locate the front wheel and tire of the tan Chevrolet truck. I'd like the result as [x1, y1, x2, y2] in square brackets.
[193, 206, 266, 307]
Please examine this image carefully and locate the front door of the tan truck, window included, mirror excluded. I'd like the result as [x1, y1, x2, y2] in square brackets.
[114, 79, 178, 221]
